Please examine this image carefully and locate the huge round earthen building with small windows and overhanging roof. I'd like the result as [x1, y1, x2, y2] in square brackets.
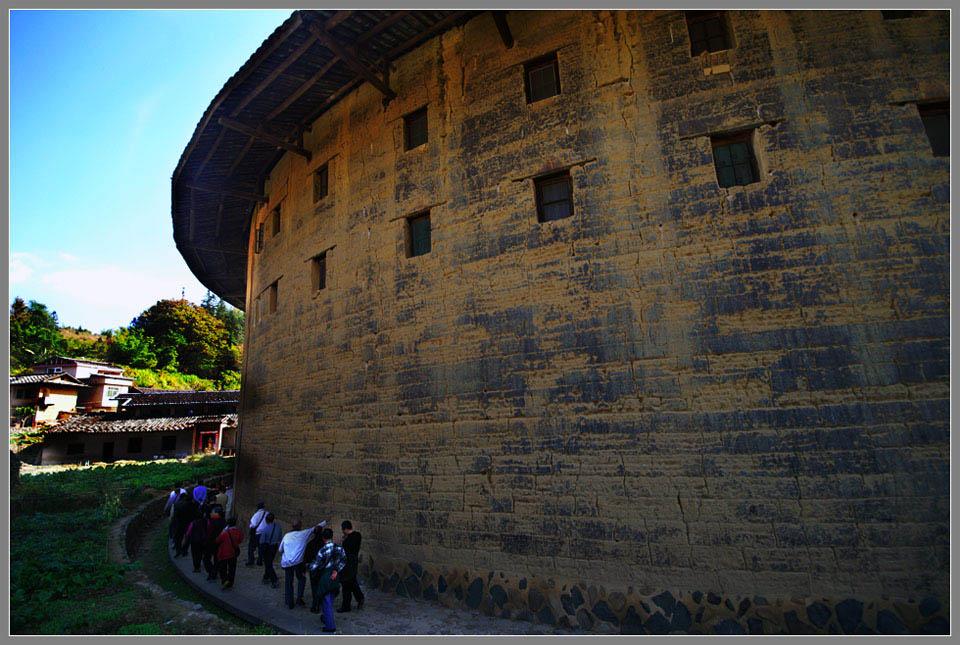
[172, 10, 950, 634]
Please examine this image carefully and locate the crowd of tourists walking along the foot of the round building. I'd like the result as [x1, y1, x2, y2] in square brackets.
[165, 482, 364, 632]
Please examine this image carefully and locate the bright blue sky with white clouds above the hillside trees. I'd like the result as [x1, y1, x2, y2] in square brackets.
[10, 10, 290, 331]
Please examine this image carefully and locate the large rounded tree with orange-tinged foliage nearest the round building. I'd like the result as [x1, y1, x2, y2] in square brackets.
[130, 299, 238, 378]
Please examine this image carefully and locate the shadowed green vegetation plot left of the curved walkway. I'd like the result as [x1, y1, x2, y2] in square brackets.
[10, 456, 249, 634]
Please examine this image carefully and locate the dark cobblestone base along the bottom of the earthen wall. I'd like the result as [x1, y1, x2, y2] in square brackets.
[361, 558, 950, 635]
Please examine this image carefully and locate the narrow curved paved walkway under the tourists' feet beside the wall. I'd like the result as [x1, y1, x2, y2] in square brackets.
[170, 544, 584, 635]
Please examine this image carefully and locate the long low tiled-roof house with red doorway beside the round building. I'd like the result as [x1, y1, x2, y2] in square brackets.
[41, 389, 239, 464]
